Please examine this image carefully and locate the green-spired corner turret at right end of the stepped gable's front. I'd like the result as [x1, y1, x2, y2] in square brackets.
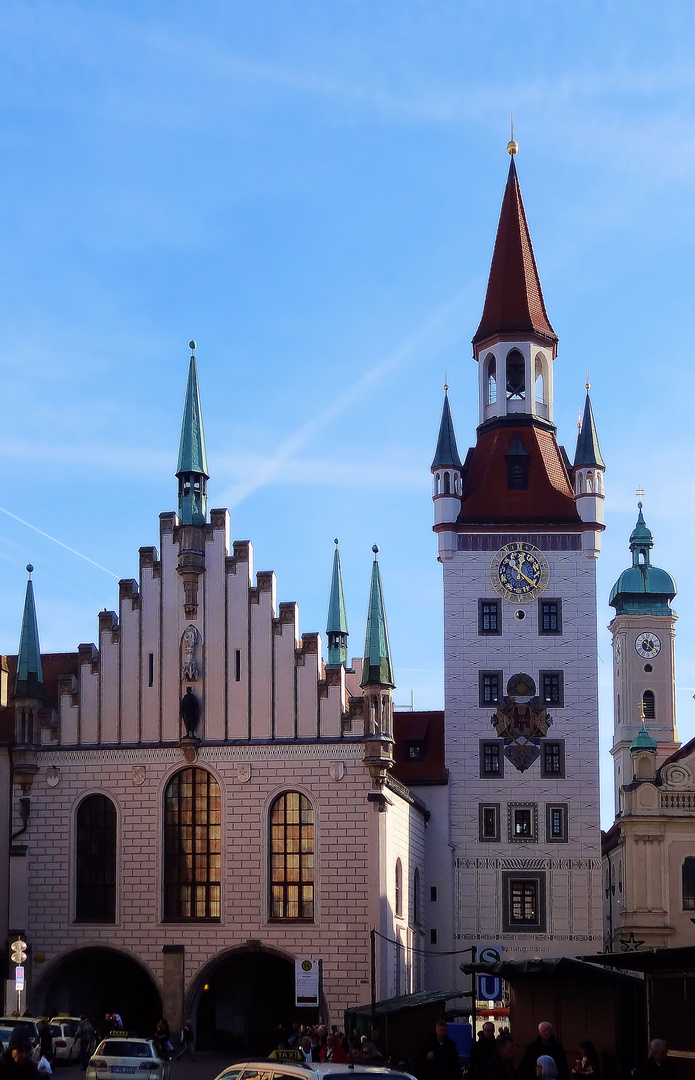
[359, 544, 395, 810]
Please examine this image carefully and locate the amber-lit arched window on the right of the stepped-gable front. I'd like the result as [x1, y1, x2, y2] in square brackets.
[270, 792, 314, 921]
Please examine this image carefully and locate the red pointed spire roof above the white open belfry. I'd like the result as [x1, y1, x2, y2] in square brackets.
[473, 157, 558, 347]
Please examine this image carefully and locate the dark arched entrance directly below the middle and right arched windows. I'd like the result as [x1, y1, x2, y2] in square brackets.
[187, 949, 318, 1057]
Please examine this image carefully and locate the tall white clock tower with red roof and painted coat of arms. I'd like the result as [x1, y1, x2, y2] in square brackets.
[432, 143, 604, 973]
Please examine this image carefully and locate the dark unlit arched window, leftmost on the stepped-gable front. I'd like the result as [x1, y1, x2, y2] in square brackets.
[74, 795, 115, 922]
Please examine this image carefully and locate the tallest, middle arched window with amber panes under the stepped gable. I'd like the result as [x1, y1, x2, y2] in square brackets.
[164, 768, 222, 920]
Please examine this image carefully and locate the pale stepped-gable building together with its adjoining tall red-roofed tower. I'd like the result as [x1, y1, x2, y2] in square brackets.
[0, 144, 677, 1050]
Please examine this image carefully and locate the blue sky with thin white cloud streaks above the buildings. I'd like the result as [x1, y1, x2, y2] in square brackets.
[0, 0, 695, 824]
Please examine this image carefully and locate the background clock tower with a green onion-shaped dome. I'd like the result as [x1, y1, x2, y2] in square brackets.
[609, 502, 679, 813]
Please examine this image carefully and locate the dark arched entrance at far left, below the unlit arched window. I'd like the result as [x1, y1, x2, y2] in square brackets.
[31, 946, 162, 1036]
